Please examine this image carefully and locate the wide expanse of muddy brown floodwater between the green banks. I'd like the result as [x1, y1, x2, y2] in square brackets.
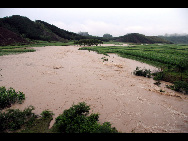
[0, 46, 188, 132]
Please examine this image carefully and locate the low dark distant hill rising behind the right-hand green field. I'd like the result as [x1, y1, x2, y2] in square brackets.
[116, 33, 171, 44]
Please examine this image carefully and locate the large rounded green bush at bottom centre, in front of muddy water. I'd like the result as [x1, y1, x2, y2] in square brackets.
[53, 102, 117, 133]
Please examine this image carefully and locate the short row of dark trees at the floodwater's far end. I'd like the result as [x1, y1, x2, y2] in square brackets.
[74, 39, 103, 46]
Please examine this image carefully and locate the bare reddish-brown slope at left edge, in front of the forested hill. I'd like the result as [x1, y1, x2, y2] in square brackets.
[0, 27, 29, 46]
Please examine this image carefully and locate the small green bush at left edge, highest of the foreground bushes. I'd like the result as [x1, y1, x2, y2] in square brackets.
[0, 86, 25, 109]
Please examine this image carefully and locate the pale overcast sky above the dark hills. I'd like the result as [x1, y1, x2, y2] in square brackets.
[0, 8, 188, 37]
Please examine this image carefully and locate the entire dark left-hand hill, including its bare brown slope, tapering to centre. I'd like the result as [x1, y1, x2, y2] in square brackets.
[0, 15, 108, 46]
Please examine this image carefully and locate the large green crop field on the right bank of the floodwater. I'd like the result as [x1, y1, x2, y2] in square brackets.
[80, 44, 188, 85]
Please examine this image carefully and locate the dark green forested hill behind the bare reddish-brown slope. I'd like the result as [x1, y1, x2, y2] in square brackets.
[0, 15, 85, 42]
